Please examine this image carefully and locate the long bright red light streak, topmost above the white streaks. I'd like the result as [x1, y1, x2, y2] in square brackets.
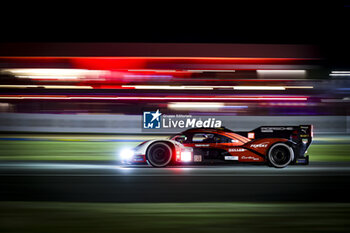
[0, 57, 316, 70]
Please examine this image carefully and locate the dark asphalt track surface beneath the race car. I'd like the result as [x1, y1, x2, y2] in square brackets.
[0, 162, 350, 202]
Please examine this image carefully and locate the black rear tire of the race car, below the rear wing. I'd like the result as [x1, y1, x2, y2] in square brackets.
[267, 143, 294, 168]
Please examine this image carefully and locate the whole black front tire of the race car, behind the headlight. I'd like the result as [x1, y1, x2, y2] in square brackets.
[147, 142, 173, 167]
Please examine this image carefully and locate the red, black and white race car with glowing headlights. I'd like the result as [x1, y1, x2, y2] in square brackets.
[121, 125, 313, 168]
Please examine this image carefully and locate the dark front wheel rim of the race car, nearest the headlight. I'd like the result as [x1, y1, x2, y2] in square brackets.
[148, 144, 171, 166]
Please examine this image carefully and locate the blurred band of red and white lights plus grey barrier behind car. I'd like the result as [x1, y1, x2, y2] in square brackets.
[0, 43, 350, 135]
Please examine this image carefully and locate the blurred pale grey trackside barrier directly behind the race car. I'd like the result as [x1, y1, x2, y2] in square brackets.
[0, 113, 350, 134]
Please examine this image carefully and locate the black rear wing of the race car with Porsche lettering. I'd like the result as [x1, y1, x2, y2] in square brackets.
[235, 125, 313, 144]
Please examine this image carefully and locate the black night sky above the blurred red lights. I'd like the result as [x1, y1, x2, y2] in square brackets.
[0, 1, 350, 66]
